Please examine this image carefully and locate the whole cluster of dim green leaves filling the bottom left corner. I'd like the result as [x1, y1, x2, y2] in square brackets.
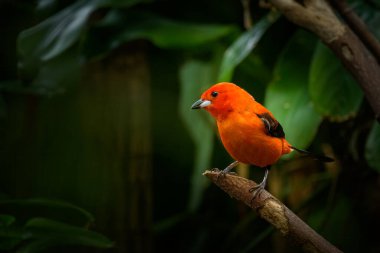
[0, 199, 113, 253]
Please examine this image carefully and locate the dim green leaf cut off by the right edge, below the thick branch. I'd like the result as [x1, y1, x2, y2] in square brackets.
[365, 122, 380, 173]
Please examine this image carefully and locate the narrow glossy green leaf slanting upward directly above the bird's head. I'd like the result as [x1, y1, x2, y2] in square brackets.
[218, 12, 280, 82]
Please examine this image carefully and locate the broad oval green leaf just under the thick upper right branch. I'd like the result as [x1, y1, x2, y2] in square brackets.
[309, 43, 363, 121]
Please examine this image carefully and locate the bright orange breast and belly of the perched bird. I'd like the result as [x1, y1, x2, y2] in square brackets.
[218, 112, 291, 167]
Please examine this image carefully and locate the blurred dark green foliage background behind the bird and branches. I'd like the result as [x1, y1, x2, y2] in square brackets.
[0, 0, 380, 252]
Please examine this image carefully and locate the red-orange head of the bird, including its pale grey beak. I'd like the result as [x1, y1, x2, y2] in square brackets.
[191, 83, 254, 120]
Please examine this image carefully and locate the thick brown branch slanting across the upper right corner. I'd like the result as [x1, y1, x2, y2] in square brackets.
[270, 0, 380, 122]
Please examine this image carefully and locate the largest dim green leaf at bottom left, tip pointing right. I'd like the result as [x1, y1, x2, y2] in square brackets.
[18, 218, 113, 253]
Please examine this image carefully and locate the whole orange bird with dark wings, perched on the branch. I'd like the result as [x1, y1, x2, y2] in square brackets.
[191, 82, 332, 197]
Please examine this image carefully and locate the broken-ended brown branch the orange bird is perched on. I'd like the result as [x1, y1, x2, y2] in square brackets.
[203, 171, 342, 253]
